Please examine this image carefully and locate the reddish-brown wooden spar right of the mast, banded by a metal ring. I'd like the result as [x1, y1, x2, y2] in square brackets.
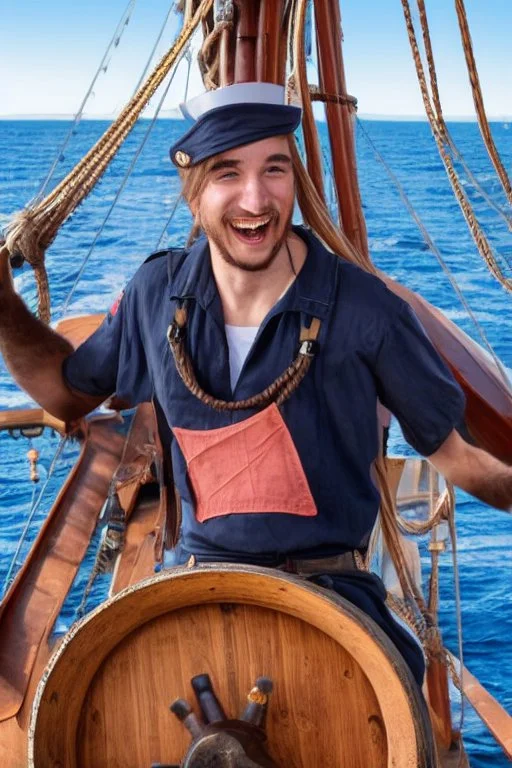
[315, 0, 369, 261]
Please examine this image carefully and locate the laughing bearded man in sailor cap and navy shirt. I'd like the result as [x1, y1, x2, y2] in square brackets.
[0, 83, 512, 682]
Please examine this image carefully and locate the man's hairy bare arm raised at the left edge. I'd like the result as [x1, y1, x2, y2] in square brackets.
[0, 247, 105, 421]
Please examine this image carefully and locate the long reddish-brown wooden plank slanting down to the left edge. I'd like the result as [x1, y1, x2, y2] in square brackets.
[0, 420, 124, 728]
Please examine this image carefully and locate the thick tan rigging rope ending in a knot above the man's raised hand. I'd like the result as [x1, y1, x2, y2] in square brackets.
[6, 0, 213, 322]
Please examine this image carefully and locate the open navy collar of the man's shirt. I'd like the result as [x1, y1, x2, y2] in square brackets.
[169, 227, 340, 319]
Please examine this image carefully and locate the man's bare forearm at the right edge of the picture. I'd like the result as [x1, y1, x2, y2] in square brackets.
[428, 430, 512, 512]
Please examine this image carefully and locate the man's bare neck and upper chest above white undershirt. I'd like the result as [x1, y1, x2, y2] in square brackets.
[210, 231, 307, 326]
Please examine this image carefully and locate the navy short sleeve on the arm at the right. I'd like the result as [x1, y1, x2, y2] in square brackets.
[375, 303, 464, 456]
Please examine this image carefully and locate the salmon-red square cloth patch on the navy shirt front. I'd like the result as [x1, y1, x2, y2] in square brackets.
[173, 404, 318, 523]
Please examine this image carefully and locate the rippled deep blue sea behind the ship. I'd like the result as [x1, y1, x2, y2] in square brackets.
[0, 120, 512, 768]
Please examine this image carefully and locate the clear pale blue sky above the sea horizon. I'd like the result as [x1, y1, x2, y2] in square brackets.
[0, 0, 512, 117]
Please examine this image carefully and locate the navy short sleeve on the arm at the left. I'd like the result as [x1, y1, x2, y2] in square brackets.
[63, 281, 152, 406]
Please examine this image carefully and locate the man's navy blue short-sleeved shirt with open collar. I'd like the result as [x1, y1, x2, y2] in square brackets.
[64, 228, 464, 559]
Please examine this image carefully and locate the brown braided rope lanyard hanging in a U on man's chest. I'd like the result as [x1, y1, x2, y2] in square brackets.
[167, 300, 321, 411]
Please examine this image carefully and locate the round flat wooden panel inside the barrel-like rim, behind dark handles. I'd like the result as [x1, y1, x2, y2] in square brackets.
[77, 605, 388, 768]
